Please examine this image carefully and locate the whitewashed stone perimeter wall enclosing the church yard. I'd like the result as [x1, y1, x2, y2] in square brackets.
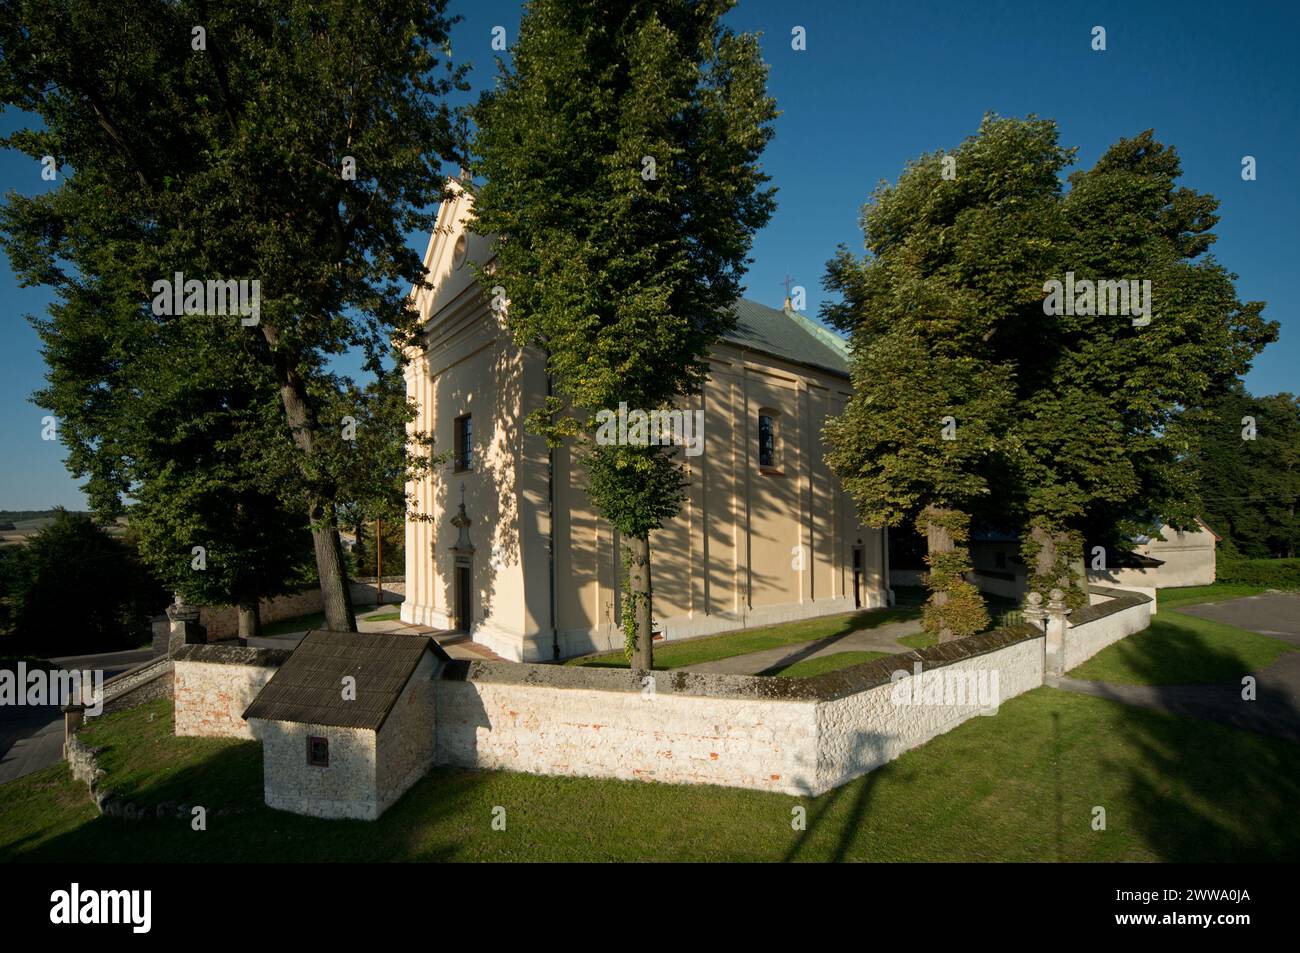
[176, 589, 1151, 795]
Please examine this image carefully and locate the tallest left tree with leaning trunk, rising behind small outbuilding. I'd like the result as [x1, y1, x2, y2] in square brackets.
[0, 0, 463, 629]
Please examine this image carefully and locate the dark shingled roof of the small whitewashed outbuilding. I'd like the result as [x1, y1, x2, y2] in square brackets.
[243, 629, 446, 731]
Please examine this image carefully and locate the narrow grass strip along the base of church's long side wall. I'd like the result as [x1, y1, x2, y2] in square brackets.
[566, 605, 920, 670]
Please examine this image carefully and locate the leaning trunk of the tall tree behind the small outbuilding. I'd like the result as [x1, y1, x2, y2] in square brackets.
[260, 321, 356, 632]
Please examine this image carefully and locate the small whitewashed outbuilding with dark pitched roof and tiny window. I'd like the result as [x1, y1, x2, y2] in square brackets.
[243, 629, 447, 820]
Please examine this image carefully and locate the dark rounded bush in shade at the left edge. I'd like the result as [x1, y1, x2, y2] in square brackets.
[0, 510, 169, 658]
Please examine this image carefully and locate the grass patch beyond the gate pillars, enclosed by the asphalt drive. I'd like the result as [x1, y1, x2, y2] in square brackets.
[1069, 597, 1295, 685]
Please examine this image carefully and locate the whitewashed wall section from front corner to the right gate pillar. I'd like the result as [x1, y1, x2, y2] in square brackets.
[811, 638, 1043, 794]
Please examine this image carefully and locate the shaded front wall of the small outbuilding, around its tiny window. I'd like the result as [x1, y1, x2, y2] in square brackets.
[254, 718, 387, 820]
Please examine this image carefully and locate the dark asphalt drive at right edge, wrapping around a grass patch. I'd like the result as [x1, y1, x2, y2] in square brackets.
[1053, 593, 1300, 742]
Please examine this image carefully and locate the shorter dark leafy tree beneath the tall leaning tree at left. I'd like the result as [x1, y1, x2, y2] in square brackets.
[23, 260, 312, 638]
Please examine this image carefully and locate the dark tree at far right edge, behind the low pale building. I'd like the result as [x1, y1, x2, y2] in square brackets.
[1191, 384, 1300, 558]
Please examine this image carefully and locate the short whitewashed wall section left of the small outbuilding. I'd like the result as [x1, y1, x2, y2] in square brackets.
[173, 645, 287, 738]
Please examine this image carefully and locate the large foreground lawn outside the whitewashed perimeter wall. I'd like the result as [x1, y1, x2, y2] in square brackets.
[0, 688, 1300, 863]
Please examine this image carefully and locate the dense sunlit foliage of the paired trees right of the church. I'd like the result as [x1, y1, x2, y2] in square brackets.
[823, 116, 1277, 601]
